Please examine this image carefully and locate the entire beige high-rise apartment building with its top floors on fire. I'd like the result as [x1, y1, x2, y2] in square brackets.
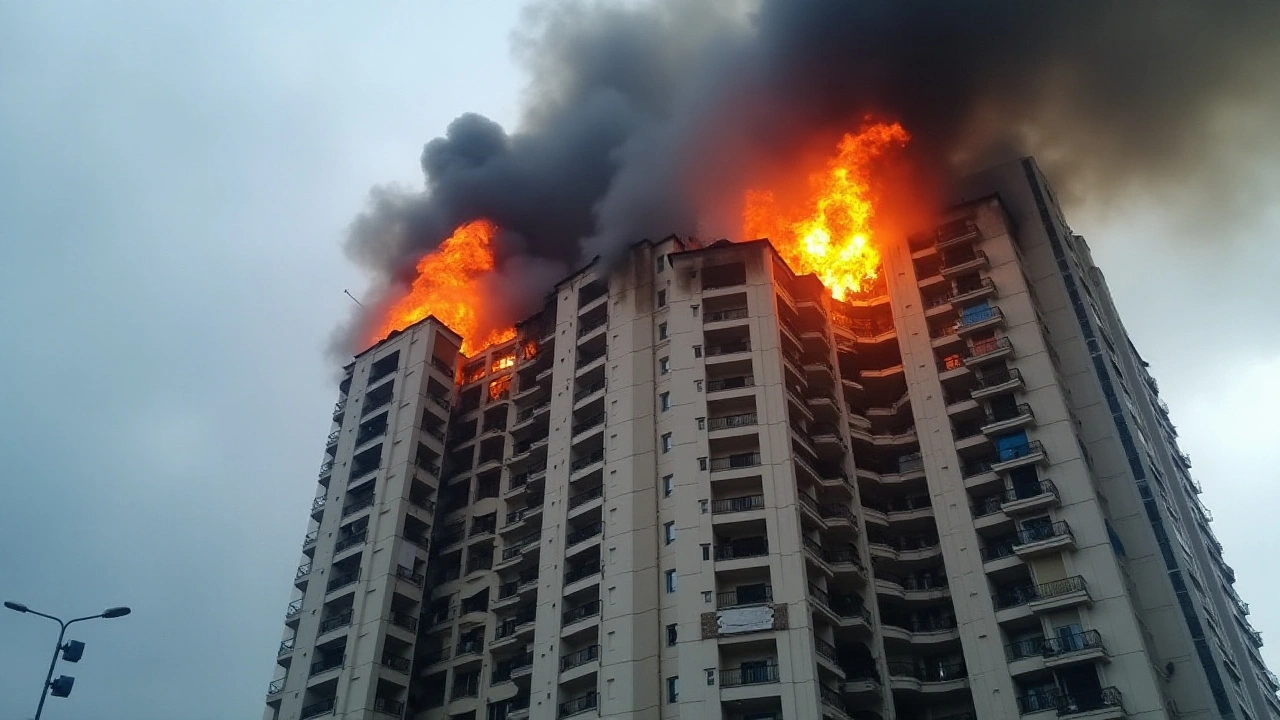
[266, 159, 1280, 720]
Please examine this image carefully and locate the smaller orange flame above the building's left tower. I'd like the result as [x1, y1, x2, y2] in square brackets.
[370, 220, 516, 355]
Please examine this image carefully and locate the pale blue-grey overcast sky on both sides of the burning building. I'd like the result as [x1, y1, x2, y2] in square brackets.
[0, 0, 1280, 720]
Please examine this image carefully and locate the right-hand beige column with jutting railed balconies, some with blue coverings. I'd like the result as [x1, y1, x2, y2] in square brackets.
[911, 194, 1164, 717]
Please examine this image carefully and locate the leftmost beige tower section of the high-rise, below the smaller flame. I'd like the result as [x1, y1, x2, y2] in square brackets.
[268, 323, 457, 720]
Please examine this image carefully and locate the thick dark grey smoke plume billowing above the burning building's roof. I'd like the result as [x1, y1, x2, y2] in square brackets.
[337, 0, 1280, 353]
